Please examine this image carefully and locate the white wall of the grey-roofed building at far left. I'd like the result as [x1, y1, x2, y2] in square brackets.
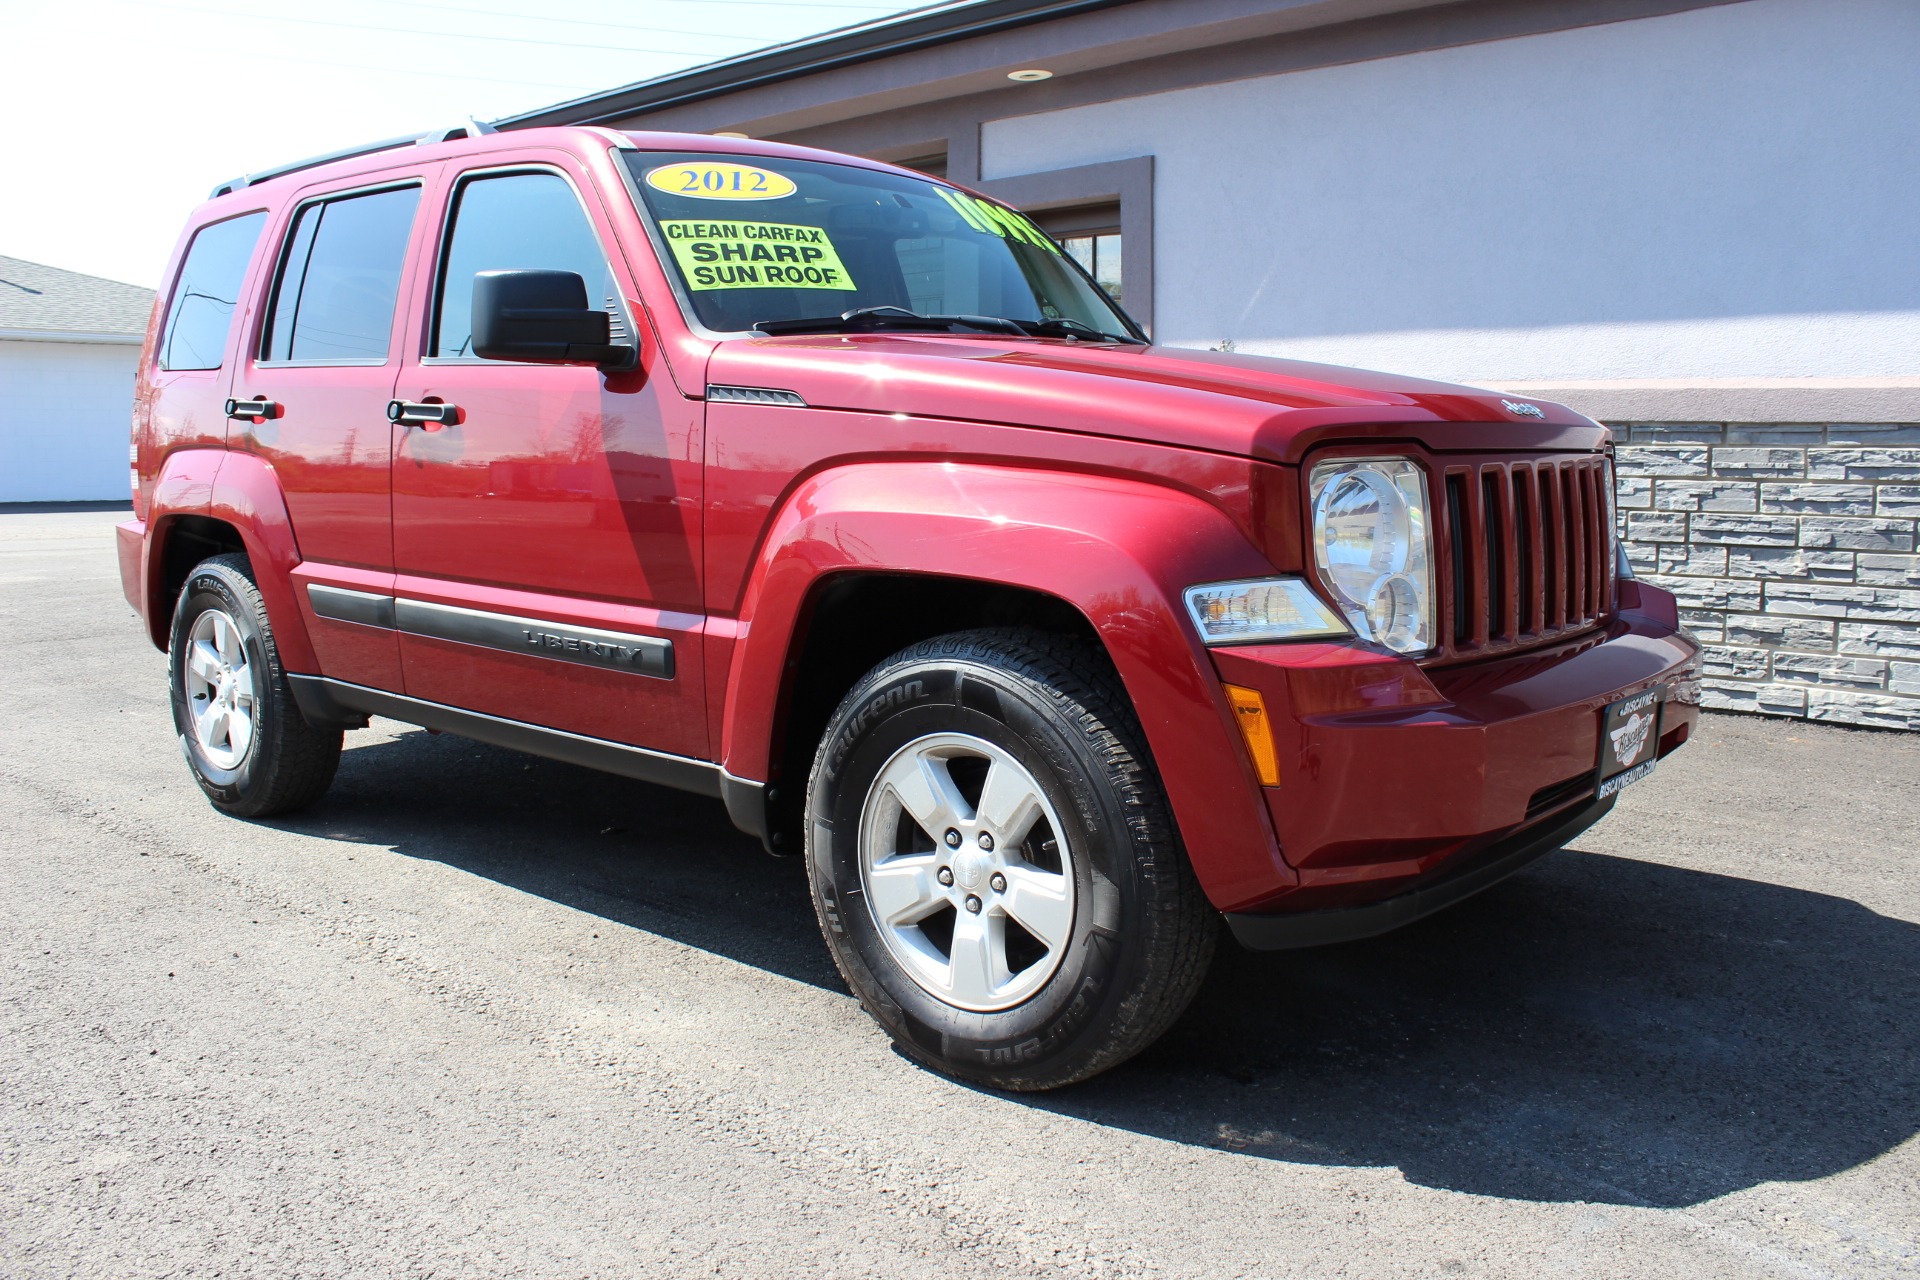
[0, 342, 140, 503]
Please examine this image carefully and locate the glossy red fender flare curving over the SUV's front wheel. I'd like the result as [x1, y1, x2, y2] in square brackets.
[720, 461, 1294, 908]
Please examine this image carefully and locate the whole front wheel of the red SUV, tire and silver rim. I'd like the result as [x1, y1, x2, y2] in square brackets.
[806, 629, 1219, 1090]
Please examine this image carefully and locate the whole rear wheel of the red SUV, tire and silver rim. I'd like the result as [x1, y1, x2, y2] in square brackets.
[167, 555, 340, 818]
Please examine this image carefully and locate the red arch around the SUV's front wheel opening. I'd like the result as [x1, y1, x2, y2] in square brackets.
[718, 462, 1292, 904]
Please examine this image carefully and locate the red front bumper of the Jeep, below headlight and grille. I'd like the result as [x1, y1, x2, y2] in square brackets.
[1213, 583, 1699, 936]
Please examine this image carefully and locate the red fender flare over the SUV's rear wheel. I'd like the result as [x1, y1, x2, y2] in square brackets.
[144, 449, 319, 672]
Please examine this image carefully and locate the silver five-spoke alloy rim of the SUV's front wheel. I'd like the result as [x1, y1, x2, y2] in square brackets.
[858, 733, 1075, 1013]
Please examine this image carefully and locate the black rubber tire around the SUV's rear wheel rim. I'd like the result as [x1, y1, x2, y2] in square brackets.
[167, 555, 342, 818]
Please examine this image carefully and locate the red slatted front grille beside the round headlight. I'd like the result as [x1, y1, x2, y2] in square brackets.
[1434, 455, 1615, 660]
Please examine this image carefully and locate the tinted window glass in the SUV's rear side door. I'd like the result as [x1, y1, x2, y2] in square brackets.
[261, 186, 420, 363]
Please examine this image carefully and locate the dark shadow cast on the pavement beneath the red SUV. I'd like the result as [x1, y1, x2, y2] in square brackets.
[276, 731, 1920, 1207]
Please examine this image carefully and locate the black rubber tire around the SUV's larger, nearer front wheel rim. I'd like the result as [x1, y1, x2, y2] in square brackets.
[806, 629, 1219, 1090]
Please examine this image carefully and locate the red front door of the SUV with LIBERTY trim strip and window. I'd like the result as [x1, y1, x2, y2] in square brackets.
[394, 152, 708, 758]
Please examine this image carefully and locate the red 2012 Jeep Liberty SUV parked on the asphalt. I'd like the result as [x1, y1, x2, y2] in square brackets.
[119, 127, 1697, 1090]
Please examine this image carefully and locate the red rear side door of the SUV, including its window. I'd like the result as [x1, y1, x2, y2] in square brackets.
[232, 171, 430, 691]
